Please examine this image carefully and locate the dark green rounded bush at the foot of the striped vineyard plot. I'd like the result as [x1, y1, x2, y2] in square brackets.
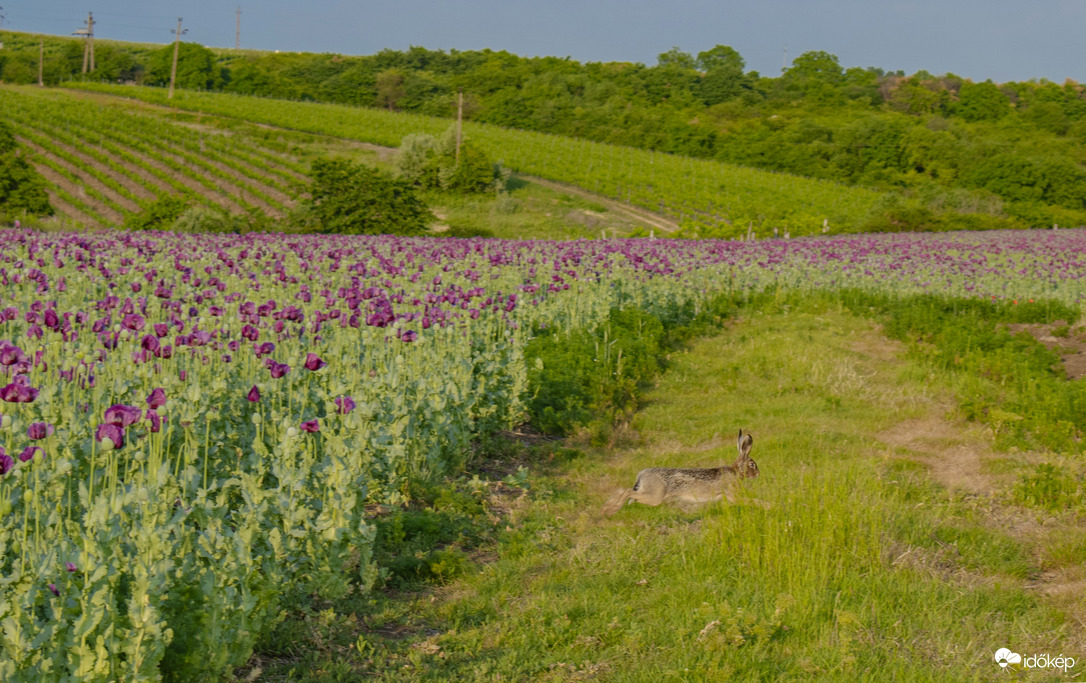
[304, 159, 433, 235]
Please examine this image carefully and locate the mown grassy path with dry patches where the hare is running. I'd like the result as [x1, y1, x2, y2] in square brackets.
[258, 311, 1086, 681]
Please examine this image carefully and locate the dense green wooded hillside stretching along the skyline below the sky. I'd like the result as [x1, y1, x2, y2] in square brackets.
[0, 34, 1086, 229]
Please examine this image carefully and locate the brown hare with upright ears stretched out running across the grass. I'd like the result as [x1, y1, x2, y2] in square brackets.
[603, 429, 769, 517]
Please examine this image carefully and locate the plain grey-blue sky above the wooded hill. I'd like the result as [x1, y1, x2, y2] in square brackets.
[8, 0, 1086, 83]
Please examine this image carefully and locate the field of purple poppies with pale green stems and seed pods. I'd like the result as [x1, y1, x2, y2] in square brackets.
[0, 230, 1086, 681]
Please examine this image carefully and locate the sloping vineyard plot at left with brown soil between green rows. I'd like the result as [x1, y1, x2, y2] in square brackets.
[0, 88, 305, 227]
